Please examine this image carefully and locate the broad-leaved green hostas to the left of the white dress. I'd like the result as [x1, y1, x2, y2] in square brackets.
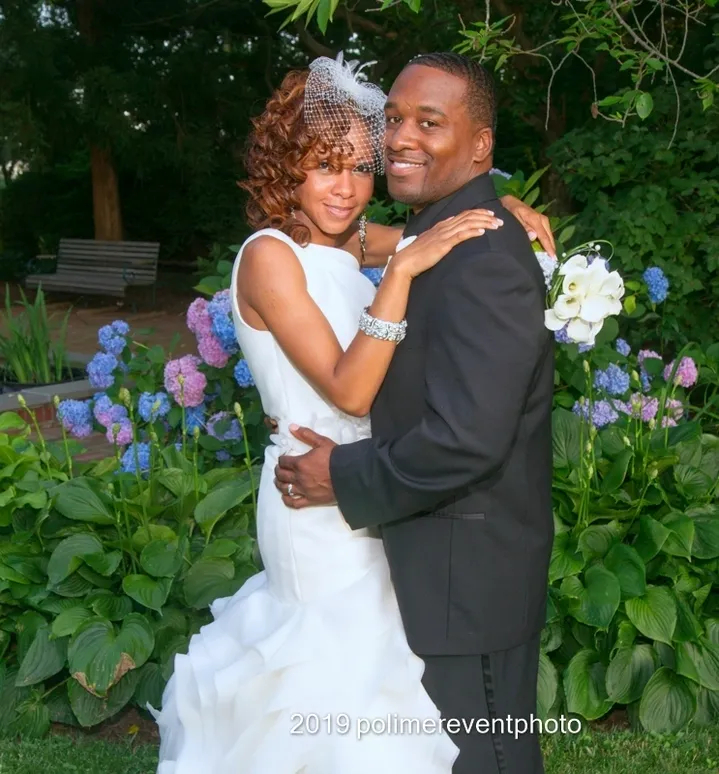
[0, 413, 257, 737]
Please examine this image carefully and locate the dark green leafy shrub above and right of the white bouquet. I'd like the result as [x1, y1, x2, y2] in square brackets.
[550, 85, 719, 347]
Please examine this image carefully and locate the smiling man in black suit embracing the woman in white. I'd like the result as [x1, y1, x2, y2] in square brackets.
[276, 54, 554, 774]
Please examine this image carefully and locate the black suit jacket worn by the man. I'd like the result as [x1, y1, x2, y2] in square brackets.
[330, 174, 554, 655]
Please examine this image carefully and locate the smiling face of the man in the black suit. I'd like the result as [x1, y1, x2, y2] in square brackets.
[385, 65, 492, 211]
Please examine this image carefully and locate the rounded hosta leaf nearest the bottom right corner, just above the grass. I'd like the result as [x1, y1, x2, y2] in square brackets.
[639, 667, 696, 734]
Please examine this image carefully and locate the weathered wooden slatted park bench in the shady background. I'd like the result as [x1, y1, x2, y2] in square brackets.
[25, 239, 160, 305]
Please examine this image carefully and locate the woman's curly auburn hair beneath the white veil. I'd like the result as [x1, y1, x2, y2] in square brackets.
[239, 70, 372, 245]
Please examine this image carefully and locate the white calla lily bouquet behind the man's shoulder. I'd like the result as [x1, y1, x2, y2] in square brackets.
[539, 242, 624, 347]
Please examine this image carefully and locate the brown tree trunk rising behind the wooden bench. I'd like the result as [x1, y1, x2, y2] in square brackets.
[77, 0, 123, 241]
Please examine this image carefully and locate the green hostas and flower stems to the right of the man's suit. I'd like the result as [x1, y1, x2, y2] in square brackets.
[539, 324, 719, 733]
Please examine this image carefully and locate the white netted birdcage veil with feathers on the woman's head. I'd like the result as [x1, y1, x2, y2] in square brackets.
[304, 52, 387, 174]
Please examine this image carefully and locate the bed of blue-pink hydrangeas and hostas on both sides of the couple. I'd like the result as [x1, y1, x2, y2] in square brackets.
[0, 235, 719, 736]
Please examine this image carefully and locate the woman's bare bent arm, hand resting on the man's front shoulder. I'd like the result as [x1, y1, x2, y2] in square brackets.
[236, 211, 500, 416]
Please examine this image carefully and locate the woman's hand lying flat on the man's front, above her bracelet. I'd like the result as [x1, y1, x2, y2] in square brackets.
[389, 210, 504, 279]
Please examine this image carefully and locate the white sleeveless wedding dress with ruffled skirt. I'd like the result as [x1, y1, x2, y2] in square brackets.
[155, 229, 458, 774]
